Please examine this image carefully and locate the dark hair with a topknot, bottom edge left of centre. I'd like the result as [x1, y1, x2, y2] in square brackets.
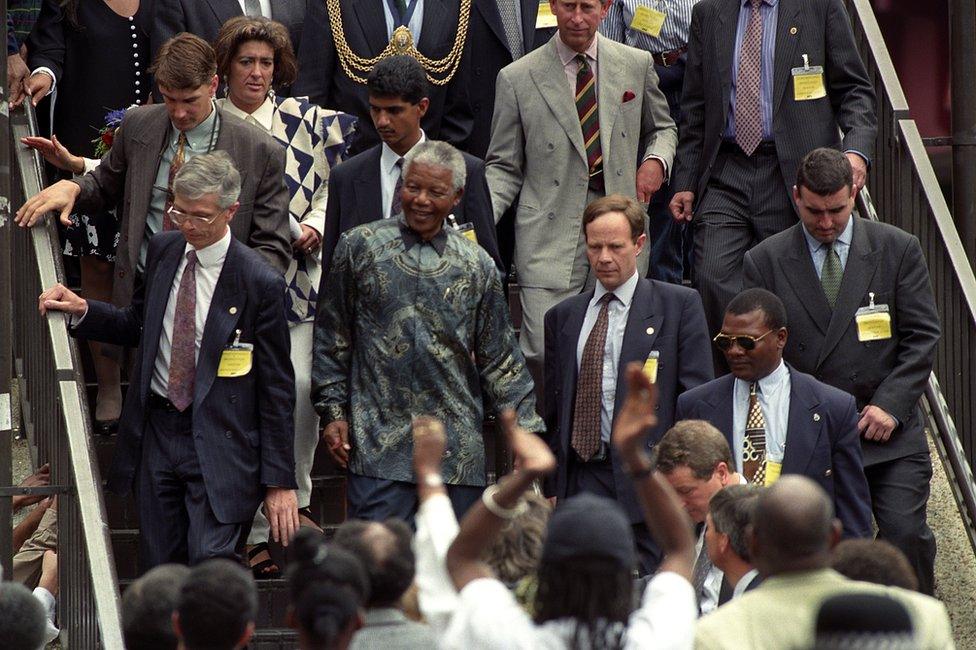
[288, 530, 369, 650]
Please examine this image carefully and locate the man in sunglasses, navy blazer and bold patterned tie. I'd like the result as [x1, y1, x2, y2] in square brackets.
[677, 289, 872, 538]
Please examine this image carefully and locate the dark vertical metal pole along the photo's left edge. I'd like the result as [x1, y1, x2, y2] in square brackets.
[0, 0, 14, 580]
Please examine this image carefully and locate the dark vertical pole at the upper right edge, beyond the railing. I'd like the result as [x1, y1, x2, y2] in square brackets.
[949, 0, 976, 260]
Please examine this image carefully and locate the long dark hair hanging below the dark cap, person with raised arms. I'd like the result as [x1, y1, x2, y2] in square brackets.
[535, 556, 634, 649]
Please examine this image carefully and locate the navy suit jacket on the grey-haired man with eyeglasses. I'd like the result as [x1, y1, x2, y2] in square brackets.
[72, 232, 296, 523]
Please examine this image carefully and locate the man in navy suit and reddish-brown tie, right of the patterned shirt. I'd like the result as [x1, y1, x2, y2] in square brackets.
[544, 195, 712, 574]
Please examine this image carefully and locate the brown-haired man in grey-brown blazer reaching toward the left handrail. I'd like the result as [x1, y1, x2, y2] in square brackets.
[17, 34, 291, 307]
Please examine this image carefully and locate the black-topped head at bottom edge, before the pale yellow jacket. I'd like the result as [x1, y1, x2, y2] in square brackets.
[814, 594, 919, 650]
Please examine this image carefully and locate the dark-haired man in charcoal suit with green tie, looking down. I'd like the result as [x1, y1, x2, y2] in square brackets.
[744, 149, 940, 593]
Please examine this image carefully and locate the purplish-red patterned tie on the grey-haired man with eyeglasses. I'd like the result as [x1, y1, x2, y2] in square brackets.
[166, 250, 197, 411]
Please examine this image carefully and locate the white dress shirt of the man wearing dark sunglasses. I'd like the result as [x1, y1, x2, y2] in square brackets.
[732, 360, 791, 472]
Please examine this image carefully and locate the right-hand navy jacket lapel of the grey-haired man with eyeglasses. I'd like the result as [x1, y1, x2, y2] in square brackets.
[193, 238, 246, 408]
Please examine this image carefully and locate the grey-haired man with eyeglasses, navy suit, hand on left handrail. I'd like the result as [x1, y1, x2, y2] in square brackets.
[40, 152, 298, 569]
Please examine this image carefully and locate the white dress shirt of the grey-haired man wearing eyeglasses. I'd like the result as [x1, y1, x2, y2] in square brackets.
[149, 228, 230, 397]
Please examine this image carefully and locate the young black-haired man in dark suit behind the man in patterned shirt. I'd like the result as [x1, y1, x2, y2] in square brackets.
[319, 55, 502, 278]
